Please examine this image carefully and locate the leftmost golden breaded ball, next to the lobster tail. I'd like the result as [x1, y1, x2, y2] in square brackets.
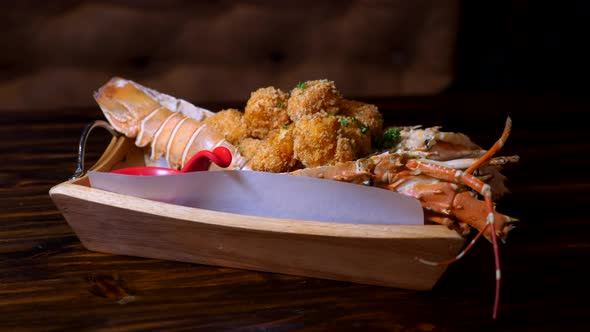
[205, 108, 248, 145]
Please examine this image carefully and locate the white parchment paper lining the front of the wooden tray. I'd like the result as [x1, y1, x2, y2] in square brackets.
[89, 170, 424, 225]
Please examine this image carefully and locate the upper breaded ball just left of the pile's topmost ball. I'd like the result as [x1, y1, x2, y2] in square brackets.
[244, 87, 291, 138]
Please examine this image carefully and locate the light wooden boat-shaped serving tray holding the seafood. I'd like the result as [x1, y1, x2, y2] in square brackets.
[49, 132, 464, 290]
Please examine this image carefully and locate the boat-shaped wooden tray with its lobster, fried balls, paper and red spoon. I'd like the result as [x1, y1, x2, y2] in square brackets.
[49, 77, 518, 316]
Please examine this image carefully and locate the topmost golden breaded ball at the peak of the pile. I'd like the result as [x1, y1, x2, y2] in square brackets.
[287, 80, 342, 122]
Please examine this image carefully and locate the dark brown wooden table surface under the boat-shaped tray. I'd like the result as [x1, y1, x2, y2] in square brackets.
[0, 96, 590, 331]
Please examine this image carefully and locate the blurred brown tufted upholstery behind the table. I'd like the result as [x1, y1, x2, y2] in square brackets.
[0, 0, 459, 110]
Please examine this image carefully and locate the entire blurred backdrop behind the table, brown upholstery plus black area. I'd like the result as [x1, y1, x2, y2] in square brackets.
[0, 0, 586, 110]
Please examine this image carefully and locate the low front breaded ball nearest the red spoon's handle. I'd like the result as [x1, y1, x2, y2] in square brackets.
[239, 126, 296, 173]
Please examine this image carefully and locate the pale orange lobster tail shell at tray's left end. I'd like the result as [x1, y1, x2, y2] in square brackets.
[94, 77, 248, 169]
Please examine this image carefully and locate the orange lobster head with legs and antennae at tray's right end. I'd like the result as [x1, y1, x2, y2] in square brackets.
[291, 118, 519, 319]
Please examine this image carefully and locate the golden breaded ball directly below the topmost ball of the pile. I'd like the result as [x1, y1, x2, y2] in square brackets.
[293, 112, 340, 167]
